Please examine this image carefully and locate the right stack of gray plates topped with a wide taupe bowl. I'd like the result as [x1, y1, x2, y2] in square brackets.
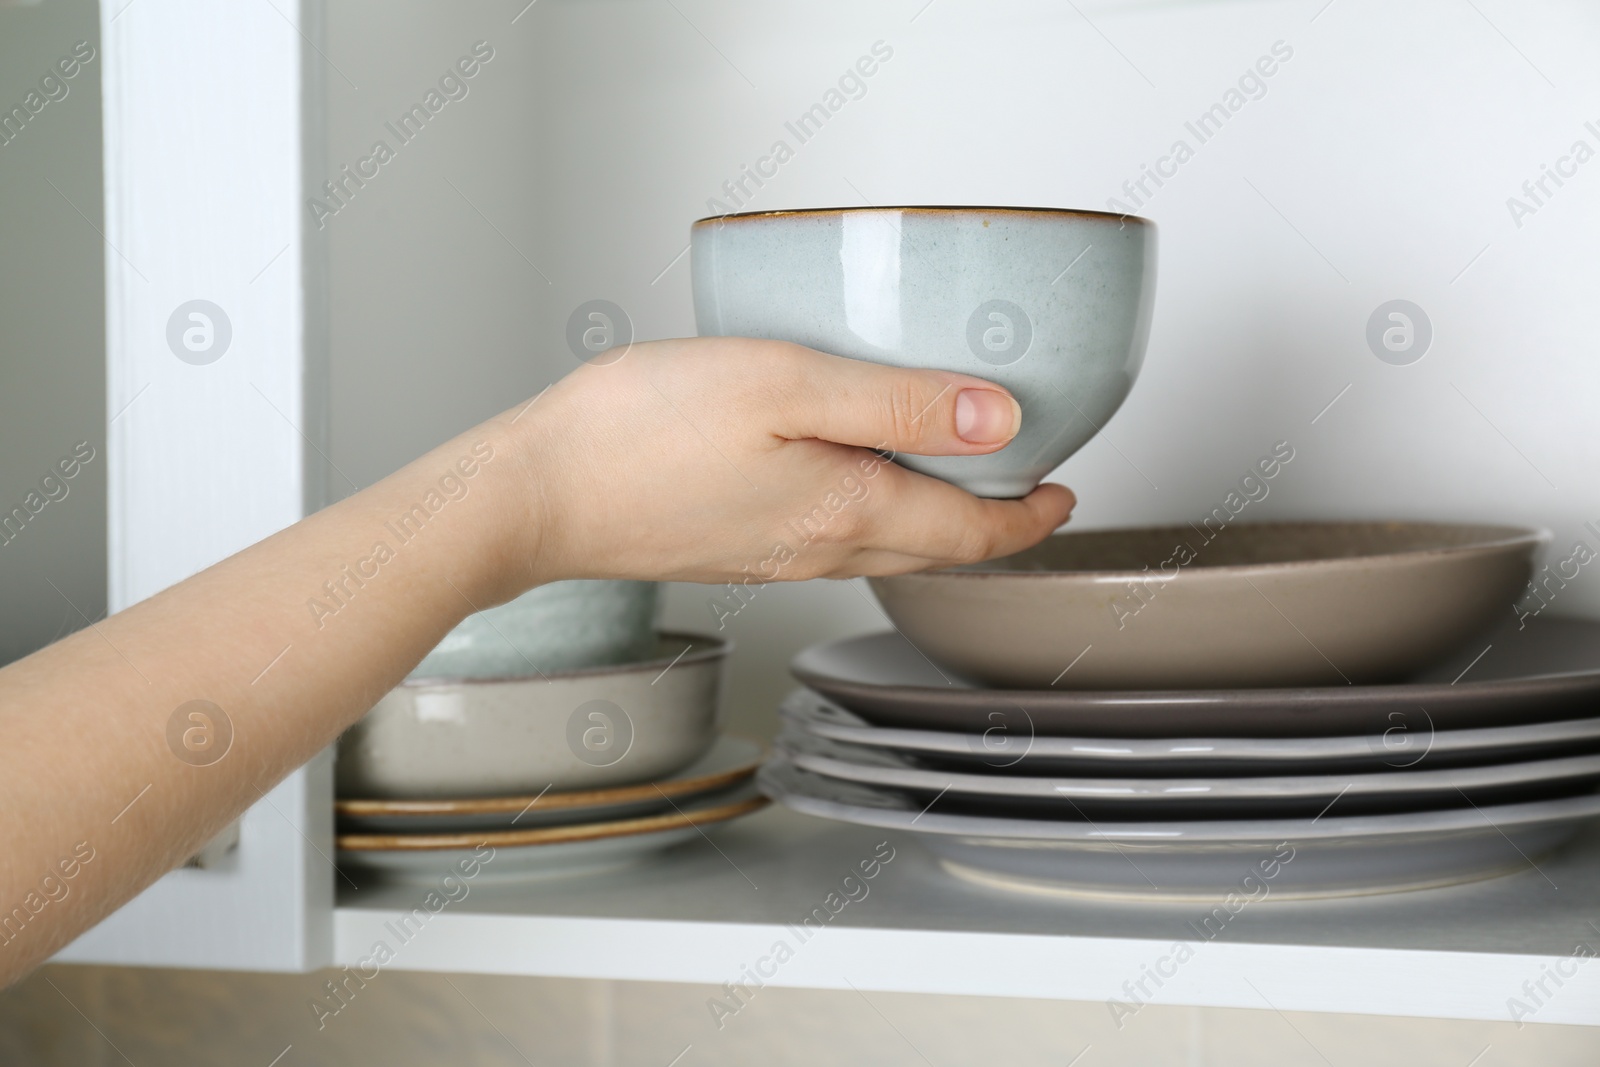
[760, 523, 1600, 899]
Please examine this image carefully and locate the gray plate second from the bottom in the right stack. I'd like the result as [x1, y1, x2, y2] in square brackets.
[778, 731, 1600, 819]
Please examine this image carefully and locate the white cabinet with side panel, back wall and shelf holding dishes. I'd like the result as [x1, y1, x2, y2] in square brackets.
[31, 0, 1600, 1022]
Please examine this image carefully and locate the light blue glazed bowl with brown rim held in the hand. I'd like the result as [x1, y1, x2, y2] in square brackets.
[691, 208, 1155, 498]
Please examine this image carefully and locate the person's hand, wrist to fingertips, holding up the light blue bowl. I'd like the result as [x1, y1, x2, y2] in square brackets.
[496, 338, 1074, 595]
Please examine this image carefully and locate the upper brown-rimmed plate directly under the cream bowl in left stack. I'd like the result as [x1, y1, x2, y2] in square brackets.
[333, 736, 765, 833]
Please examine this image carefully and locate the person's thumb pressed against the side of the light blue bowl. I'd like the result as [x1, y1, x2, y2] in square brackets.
[774, 346, 1022, 456]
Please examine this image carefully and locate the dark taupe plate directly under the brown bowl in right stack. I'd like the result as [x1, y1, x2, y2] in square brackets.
[789, 608, 1600, 739]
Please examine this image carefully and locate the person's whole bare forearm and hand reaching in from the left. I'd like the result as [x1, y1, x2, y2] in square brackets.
[0, 338, 1072, 985]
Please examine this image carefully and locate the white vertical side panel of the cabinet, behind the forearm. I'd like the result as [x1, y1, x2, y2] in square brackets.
[59, 0, 334, 969]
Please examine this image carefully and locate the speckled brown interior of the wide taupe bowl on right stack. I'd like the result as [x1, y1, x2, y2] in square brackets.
[950, 523, 1542, 574]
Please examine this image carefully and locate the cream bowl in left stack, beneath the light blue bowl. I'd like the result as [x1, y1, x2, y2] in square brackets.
[347, 633, 730, 798]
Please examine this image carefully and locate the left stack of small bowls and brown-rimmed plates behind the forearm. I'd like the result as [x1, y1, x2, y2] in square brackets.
[334, 582, 766, 883]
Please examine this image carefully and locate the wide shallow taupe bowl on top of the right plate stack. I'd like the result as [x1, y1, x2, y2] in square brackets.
[872, 512, 1549, 689]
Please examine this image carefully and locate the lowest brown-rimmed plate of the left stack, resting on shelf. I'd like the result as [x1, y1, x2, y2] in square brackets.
[338, 785, 766, 885]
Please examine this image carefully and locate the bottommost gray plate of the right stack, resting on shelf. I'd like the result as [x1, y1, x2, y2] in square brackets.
[757, 758, 1600, 901]
